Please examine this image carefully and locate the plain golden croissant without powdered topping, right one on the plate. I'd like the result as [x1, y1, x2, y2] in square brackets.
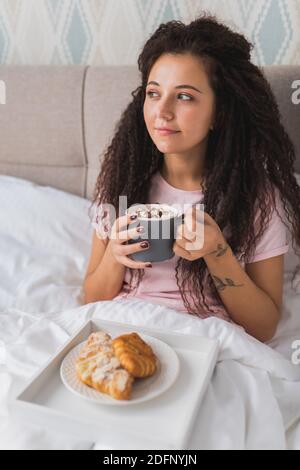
[112, 333, 157, 377]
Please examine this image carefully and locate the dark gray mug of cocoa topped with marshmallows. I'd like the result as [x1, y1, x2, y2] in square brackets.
[123, 204, 184, 263]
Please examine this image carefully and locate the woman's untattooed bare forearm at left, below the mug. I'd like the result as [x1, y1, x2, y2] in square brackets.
[83, 242, 126, 303]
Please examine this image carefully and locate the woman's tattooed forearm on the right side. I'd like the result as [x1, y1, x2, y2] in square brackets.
[204, 239, 280, 342]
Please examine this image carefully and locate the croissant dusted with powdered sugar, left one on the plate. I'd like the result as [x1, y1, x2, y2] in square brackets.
[76, 331, 134, 400]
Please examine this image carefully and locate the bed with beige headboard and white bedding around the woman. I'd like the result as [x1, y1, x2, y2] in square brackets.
[0, 66, 300, 449]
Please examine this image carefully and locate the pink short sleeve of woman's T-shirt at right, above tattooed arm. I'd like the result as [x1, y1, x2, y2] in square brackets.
[245, 189, 289, 263]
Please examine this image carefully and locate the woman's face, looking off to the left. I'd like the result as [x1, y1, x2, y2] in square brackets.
[144, 54, 215, 155]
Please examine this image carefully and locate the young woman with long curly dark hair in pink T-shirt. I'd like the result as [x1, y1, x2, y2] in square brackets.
[84, 15, 300, 341]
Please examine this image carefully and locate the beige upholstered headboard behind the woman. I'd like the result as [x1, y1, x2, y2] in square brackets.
[0, 65, 300, 198]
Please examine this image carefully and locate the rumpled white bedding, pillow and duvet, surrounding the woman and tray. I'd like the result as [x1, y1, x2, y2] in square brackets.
[0, 176, 300, 449]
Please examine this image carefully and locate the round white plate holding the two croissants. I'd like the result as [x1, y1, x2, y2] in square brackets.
[60, 334, 179, 406]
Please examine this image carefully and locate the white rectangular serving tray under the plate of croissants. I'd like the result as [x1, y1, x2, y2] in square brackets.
[11, 319, 218, 450]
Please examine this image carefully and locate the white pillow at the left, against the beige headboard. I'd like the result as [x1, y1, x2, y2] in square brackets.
[0, 176, 92, 312]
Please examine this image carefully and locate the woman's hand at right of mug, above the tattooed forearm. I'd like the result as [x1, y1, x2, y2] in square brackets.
[173, 207, 226, 261]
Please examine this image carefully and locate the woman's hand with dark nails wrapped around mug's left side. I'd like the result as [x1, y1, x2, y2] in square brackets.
[110, 214, 152, 269]
